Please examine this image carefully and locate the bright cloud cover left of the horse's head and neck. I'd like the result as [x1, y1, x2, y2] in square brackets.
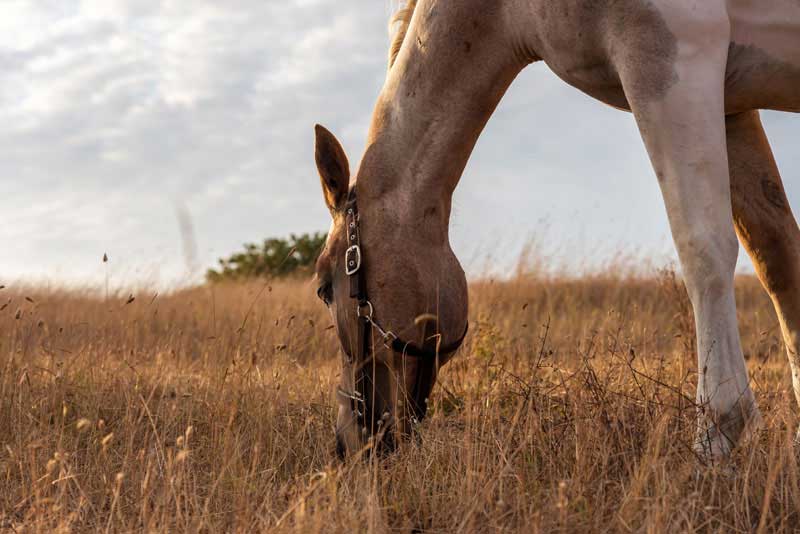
[0, 0, 386, 286]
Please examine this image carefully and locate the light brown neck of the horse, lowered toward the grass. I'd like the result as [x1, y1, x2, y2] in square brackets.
[358, 0, 526, 216]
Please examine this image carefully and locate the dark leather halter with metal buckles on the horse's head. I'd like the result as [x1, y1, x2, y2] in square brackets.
[337, 187, 469, 431]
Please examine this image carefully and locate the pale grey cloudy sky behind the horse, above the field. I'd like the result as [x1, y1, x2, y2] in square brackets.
[0, 0, 800, 284]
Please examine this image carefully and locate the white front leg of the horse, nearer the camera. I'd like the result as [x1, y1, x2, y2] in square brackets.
[619, 7, 760, 458]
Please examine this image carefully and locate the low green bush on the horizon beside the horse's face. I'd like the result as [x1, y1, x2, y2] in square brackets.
[206, 232, 327, 282]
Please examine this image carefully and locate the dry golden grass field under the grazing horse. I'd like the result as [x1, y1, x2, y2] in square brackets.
[0, 270, 800, 534]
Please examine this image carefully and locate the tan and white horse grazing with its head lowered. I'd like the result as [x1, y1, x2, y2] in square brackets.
[315, 0, 800, 458]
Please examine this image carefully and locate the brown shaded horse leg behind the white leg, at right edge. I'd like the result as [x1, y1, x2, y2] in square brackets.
[726, 111, 800, 439]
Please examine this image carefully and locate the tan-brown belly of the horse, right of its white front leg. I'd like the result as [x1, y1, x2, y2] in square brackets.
[725, 0, 800, 113]
